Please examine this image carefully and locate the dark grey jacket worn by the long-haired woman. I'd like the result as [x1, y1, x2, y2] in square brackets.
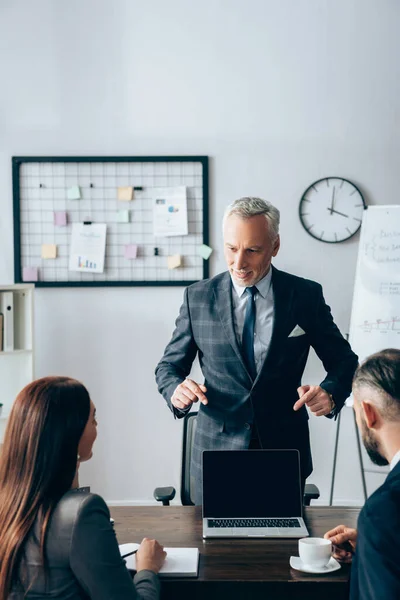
[9, 490, 159, 600]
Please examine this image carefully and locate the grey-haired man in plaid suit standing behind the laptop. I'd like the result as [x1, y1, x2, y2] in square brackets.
[156, 198, 357, 504]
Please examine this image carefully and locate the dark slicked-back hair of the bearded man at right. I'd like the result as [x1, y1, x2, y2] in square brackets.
[353, 348, 400, 421]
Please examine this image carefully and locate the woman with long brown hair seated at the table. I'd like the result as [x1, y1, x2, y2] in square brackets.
[0, 377, 165, 600]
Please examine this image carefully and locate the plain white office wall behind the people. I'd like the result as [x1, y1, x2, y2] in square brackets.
[0, 0, 400, 503]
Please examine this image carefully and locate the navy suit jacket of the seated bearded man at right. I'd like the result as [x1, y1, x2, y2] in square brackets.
[350, 463, 400, 600]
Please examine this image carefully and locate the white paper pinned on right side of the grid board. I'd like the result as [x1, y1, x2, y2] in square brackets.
[153, 185, 188, 237]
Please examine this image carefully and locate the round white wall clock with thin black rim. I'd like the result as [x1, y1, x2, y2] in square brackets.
[299, 177, 366, 244]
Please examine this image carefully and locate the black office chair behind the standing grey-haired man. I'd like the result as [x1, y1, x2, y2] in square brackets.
[153, 412, 320, 506]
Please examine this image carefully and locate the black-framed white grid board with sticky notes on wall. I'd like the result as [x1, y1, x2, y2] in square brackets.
[12, 156, 211, 287]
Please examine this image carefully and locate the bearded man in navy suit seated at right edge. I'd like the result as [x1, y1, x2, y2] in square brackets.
[325, 349, 400, 600]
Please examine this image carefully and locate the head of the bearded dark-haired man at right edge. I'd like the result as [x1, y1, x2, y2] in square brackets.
[353, 348, 400, 466]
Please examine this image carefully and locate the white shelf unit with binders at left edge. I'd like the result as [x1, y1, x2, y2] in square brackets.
[0, 284, 35, 444]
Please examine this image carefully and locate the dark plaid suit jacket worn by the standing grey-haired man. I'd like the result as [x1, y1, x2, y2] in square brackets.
[156, 268, 357, 503]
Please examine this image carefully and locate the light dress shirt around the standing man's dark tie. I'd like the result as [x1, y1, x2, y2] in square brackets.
[232, 268, 274, 373]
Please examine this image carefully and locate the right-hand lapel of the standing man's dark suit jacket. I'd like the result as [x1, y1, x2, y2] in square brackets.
[256, 267, 293, 381]
